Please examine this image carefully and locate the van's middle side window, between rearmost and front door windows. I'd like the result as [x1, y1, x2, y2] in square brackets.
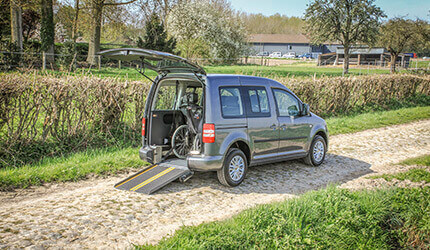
[247, 87, 270, 116]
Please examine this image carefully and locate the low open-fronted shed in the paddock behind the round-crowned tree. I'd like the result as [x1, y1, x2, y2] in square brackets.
[318, 46, 411, 68]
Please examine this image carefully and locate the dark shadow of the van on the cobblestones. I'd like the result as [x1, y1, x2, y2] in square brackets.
[158, 154, 373, 195]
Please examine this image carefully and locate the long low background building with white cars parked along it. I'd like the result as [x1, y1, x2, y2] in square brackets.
[248, 34, 340, 55]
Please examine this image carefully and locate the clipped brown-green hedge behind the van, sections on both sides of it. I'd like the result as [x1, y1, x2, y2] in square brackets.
[0, 74, 430, 168]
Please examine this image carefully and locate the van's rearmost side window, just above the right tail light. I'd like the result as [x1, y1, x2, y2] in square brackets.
[219, 87, 243, 117]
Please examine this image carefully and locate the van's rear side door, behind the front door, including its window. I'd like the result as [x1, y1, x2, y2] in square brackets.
[241, 78, 279, 160]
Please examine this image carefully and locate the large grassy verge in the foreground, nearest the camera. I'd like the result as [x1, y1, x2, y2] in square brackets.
[141, 187, 430, 249]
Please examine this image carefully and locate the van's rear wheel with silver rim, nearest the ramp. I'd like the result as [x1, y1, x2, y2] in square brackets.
[217, 148, 248, 187]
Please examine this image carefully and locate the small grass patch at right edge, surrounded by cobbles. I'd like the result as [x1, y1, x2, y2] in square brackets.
[369, 155, 430, 183]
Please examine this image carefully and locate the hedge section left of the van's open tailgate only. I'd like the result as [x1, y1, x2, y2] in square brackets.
[0, 74, 148, 167]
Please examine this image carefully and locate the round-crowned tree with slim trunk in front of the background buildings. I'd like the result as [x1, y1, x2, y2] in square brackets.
[304, 0, 385, 74]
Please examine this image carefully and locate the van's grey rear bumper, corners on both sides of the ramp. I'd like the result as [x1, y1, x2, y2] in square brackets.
[139, 146, 223, 171]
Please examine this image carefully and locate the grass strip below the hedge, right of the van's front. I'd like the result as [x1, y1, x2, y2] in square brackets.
[326, 106, 430, 135]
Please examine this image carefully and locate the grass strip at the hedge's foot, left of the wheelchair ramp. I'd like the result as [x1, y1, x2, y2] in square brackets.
[0, 147, 144, 190]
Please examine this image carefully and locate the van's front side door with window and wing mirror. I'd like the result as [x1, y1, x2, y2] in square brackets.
[272, 88, 311, 156]
